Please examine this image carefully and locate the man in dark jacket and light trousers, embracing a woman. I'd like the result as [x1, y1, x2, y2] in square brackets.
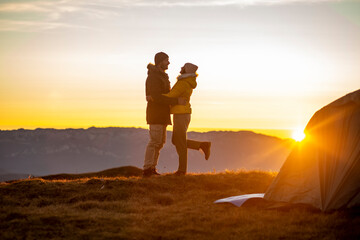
[143, 52, 186, 177]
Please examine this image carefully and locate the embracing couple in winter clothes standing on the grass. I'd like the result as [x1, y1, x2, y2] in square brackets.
[143, 52, 211, 177]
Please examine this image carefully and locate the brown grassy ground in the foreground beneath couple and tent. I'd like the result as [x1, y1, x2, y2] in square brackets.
[0, 168, 360, 239]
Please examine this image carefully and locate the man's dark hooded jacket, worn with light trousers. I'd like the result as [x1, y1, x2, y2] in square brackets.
[146, 63, 178, 125]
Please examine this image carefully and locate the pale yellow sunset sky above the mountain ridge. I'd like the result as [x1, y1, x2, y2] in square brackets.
[0, 0, 360, 137]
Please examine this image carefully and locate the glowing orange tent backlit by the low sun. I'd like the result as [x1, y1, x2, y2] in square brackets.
[264, 89, 360, 211]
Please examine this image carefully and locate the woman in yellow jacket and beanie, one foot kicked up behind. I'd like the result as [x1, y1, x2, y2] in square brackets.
[163, 63, 211, 175]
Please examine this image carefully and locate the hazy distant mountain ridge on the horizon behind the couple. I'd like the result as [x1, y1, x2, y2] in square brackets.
[0, 127, 294, 176]
